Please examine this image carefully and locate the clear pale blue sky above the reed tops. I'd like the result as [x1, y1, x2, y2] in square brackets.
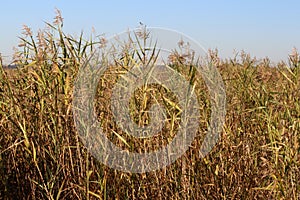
[0, 0, 300, 64]
